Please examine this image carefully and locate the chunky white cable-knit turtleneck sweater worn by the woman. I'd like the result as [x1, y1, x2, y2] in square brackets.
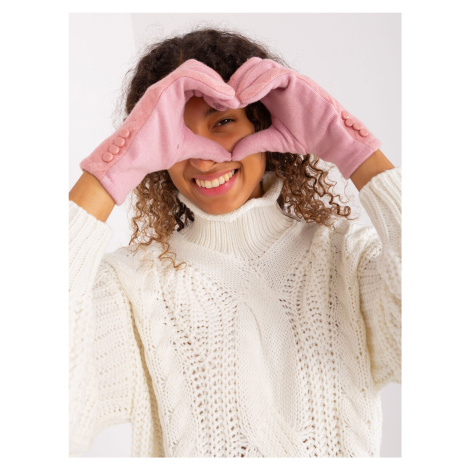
[70, 169, 401, 457]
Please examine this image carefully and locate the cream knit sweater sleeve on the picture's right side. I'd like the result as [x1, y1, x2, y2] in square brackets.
[358, 168, 401, 389]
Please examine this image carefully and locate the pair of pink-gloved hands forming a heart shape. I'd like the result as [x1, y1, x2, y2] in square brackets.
[80, 57, 380, 204]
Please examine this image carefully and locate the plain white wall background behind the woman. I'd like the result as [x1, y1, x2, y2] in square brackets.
[69, 13, 401, 457]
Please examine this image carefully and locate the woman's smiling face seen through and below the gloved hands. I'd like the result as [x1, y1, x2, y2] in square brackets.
[168, 96, 266, 215]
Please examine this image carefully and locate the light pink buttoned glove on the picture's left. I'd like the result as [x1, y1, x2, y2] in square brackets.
[80, 59, 239, 205]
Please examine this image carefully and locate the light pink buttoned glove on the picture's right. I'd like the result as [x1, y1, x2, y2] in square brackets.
[228, 57, 380, 178]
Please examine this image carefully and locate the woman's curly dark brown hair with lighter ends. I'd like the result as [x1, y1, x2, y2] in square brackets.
[123, 28, 351, 269]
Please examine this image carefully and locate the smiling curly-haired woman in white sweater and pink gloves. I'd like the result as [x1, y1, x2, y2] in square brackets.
[70, 26, 401, 457]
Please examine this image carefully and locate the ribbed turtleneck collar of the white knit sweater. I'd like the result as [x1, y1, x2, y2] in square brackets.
[176, 171, 295, 258]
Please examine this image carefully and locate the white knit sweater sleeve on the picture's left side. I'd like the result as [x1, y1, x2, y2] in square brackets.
[69, 202, 144, 456]
